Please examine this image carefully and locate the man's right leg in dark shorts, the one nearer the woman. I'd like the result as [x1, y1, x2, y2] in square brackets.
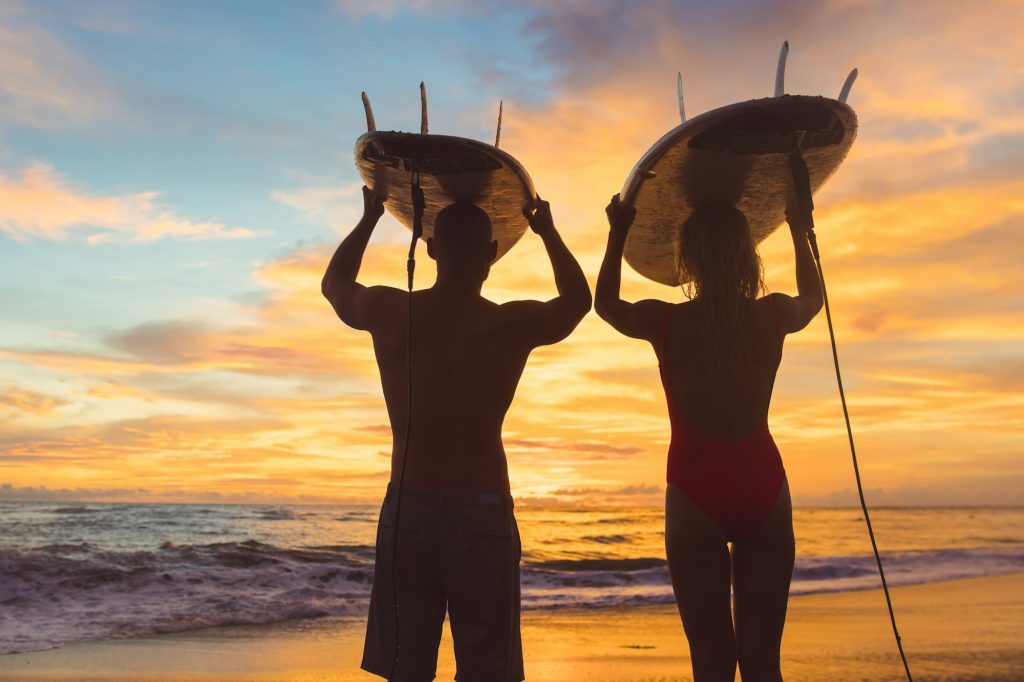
[444, 495, 523, 682]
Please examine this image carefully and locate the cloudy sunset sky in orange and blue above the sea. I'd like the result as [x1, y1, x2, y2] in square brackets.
[0, 0, 1024, 505]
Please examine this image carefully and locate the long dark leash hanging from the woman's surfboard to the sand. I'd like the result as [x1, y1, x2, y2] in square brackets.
[791, 143, 913, 682]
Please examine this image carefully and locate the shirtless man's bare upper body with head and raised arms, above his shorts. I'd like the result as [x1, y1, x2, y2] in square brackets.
[323, 193, 591, 493]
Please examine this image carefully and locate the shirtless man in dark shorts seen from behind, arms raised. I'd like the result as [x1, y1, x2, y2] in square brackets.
[322, 187, 591, 682]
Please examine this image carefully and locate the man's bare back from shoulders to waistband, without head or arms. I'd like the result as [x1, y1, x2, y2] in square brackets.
[372, 286, 544, 493]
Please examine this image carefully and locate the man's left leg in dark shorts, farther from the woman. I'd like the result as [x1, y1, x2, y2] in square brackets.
[361, 491, 444, 682]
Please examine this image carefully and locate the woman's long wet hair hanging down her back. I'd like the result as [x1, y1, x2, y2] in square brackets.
[678, 204, 765, 374]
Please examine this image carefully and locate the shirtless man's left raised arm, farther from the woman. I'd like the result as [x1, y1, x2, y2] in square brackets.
[321, 186, 390, 330]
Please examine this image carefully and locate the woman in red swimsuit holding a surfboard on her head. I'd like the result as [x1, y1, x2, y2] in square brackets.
[595, 153, 822, 682]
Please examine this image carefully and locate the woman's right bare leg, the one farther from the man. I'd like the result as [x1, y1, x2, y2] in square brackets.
[732, 480, 795, 682]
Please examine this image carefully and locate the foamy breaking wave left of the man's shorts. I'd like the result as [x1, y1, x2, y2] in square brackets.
[0, 541, 373, 653]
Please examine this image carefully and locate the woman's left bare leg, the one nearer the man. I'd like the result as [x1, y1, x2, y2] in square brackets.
[665, 483, 736, 682]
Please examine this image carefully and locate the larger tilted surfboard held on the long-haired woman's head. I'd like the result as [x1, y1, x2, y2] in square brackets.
[621, 95, 857, 287]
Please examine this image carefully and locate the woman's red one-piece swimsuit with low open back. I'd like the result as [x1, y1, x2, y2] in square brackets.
[658, 298, 785, 542]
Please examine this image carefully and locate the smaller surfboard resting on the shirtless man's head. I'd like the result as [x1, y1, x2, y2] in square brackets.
[355, 130, 537, 260]
